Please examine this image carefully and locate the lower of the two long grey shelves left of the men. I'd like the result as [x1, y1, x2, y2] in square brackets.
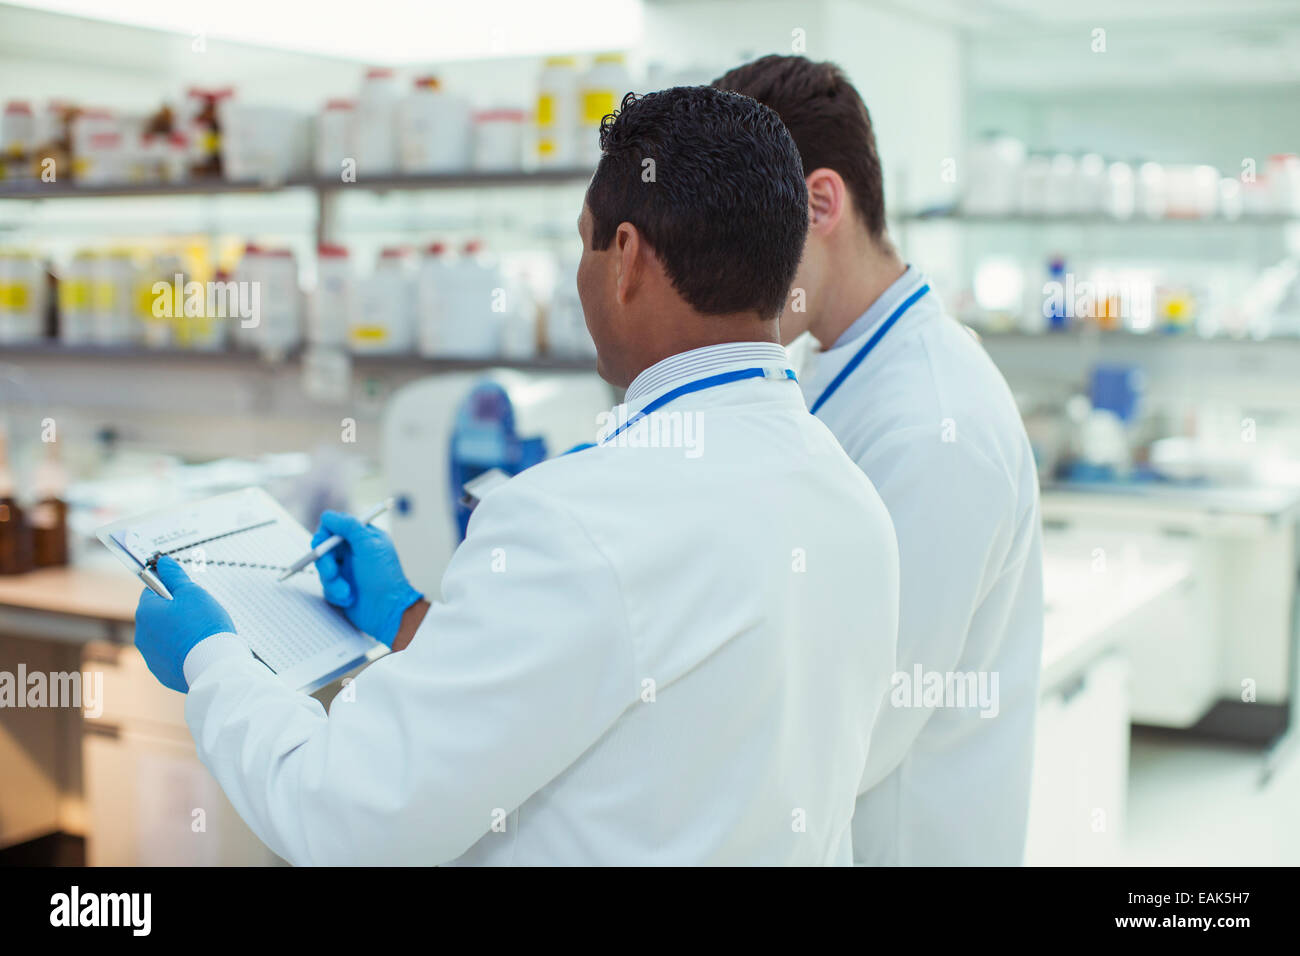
[0, 343, 595, 372]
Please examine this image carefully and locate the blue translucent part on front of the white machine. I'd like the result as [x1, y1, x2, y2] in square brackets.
[447, 381, 546, 541]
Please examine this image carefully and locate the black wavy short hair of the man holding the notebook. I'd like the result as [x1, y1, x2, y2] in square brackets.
[586, 86, 809, 319]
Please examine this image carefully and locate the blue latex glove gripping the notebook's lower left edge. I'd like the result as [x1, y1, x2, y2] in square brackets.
[135, 555, 235, 693]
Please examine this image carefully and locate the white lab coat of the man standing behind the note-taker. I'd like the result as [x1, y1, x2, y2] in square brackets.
[800, 277, 1043, 865]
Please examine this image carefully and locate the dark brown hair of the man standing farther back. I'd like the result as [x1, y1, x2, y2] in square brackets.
[714, 55, 885, 239]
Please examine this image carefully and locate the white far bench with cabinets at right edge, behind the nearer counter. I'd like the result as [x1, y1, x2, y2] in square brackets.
[1043, 481, 1300, 779]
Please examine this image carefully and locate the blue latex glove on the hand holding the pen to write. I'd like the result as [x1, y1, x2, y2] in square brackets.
[312, 511, 424, 648]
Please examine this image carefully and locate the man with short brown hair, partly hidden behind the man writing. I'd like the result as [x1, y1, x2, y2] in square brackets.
[714, 56, 1043, 865]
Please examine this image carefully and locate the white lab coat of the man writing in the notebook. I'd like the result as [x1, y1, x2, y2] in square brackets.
[186, 350, 897, 864]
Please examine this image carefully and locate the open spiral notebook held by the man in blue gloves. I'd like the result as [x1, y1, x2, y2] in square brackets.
[96, 488, 387, 693]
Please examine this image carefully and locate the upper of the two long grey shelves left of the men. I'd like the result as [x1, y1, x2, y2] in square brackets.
[0, 166, 593, 200]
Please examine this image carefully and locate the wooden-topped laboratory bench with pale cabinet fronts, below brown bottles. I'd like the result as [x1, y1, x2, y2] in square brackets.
[0, 554, 276, 865]
